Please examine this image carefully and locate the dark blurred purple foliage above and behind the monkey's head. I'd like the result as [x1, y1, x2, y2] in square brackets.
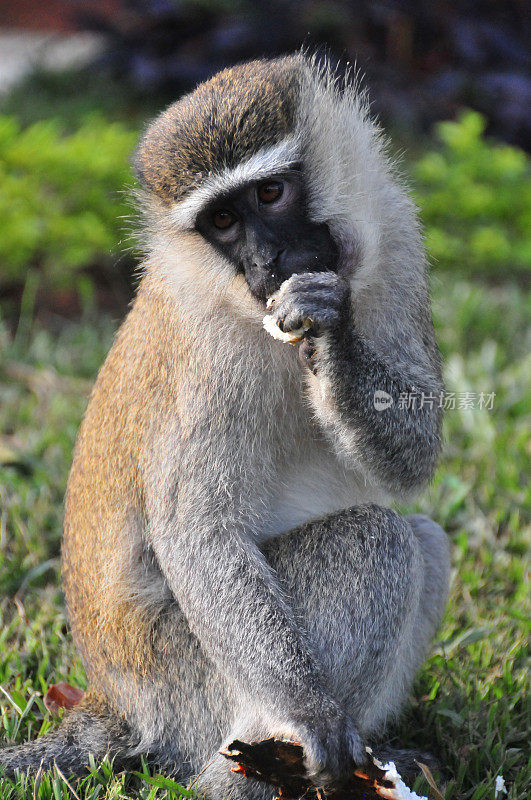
[77, 0, 531, 148]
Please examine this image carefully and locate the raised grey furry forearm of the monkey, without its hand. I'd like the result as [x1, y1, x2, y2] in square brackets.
[314, 328, 441, 492]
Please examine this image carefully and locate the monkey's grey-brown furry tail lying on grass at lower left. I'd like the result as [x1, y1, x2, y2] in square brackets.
[0, 691, 134, 777]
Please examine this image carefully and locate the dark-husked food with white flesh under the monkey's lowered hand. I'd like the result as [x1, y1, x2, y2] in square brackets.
[220, 738, 426, 800]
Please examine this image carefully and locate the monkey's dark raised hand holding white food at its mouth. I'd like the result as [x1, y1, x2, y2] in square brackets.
[264, 272, 350, 344]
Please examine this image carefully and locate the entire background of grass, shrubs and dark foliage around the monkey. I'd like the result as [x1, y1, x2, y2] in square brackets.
[0, 0, 531, 800]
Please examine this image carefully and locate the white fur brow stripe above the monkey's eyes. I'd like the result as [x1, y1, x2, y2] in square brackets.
[171, 137, 299, 229]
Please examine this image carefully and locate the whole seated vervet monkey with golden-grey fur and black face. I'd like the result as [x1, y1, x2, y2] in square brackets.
[0, 54, 449, 800]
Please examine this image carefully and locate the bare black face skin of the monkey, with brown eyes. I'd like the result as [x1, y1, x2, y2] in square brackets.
[196, 170, 338, 303]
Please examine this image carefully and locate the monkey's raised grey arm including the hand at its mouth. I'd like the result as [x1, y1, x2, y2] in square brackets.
[266, 273, 442, 492]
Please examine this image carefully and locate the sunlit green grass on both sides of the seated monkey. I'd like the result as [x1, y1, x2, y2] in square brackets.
[0, 276, 531, 800]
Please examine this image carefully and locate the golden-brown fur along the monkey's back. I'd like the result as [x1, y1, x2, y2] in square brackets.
[63, 282, 191, 680]
